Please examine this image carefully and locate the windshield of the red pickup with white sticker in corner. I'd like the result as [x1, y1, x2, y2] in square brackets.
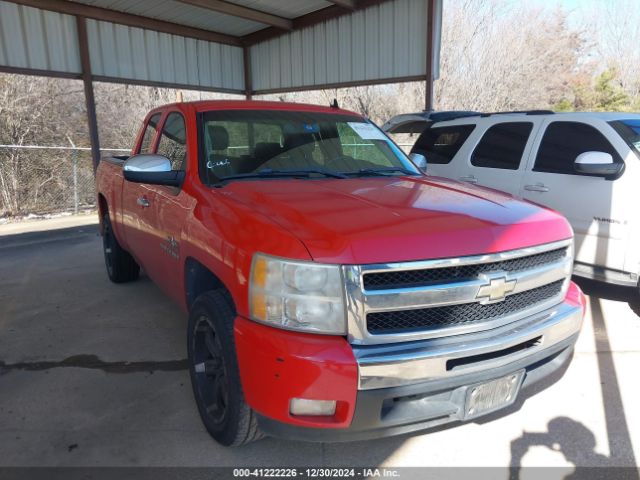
[200, 110, 420, 183]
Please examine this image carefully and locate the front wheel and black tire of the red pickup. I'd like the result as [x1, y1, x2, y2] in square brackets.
[187, 290, 263, 447]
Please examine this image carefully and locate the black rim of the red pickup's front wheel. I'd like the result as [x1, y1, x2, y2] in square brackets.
[192, 315, 229, 425]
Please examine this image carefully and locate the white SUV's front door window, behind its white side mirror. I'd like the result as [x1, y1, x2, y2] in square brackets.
[533, 121, 622, 176]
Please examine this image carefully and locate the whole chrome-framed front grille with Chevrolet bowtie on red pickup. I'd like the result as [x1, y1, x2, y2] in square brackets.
[342, 240, 573, 344]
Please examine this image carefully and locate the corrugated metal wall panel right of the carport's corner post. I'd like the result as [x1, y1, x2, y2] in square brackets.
[251, 0, 427, 90]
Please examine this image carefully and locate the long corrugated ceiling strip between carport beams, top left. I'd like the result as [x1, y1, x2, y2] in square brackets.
[71, 0, 265, 36]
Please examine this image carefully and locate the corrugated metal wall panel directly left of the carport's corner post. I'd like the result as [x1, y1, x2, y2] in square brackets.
[87, 20, 244, 91]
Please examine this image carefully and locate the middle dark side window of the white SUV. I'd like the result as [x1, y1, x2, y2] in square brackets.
[471, 122, 533, 170]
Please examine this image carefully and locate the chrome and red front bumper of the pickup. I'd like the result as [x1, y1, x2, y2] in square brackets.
[236, 284, 584, 441]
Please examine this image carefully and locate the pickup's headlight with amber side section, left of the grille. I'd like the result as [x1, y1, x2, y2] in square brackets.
[249, 253, 347, 335]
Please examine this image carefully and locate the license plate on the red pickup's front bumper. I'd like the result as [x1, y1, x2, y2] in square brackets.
[464, 370, 524, 419]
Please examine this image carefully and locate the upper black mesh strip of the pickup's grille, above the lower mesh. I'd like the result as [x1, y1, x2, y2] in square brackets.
[363, 247, 567, 290]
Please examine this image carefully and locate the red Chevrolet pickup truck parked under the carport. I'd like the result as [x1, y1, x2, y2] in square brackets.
[97, 101, 585, 445]
